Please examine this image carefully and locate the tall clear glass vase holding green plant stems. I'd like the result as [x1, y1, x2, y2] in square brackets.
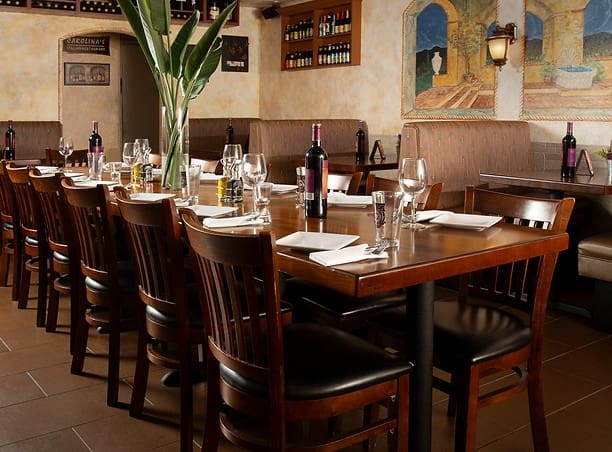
[161, 107, 189, 192]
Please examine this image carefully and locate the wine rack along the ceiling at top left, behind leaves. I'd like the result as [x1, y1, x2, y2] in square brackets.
[0, 0, 240, 26]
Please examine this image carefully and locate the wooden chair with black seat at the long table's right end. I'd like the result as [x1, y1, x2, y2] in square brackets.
[368, 186, 574, 452]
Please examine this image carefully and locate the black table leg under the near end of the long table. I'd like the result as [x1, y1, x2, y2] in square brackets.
[406, 281, 434, 452]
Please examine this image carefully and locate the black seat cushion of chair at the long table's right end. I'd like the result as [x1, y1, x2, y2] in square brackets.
[434, 302, 531, 370]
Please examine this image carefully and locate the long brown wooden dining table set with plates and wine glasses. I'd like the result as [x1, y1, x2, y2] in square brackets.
[62, 167, 568, 452]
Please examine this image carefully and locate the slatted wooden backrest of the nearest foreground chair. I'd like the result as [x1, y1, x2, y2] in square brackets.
[182, 216, 282, 385]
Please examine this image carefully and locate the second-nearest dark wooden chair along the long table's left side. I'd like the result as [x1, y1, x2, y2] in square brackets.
[115, 196, 206, 451]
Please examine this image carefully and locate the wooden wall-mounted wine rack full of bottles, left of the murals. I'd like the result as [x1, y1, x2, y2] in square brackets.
[279, 0, 361, 71]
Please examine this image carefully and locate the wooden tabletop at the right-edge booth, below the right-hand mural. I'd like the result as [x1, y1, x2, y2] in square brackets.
[480, 168, 612, 197]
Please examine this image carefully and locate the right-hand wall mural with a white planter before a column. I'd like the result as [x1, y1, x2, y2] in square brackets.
[522, 0, 612, 121]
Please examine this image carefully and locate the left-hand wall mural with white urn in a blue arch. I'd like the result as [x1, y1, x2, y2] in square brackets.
[402, 0, 497, 118]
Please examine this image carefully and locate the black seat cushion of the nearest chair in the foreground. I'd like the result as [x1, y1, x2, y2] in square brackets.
[221, 323, 413, 400]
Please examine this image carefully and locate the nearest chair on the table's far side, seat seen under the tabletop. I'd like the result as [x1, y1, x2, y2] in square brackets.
[285, 179, 444, 333]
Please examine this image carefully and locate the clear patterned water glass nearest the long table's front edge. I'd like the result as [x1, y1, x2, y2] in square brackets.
[372, 191, 404, 247]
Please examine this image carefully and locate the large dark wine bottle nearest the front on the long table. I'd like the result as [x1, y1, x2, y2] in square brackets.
[304, 124, 328, 218]
